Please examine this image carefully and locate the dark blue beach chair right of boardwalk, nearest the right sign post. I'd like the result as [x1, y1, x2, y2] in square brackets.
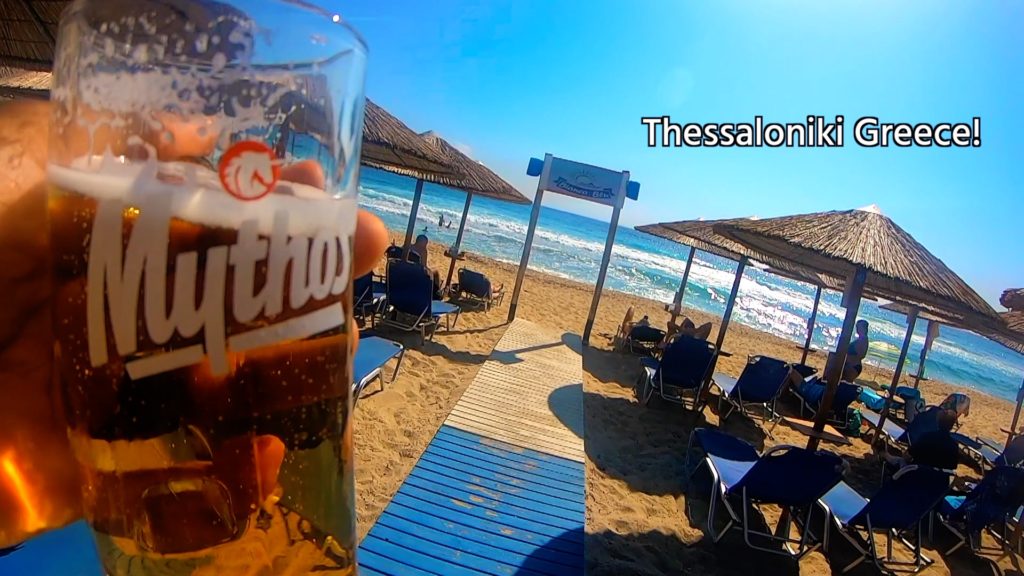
[636, 335, 717, 410]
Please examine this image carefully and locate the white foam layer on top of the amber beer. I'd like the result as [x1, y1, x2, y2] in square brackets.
[47, 156, 357, 236]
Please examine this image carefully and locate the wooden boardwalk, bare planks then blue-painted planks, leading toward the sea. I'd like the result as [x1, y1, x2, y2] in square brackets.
[358, 320, 586, 576]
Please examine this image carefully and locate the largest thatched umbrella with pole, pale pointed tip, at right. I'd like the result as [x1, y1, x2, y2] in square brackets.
[715, 206, 995, 448]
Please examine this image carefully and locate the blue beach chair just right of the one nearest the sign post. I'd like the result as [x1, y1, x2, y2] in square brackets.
[712, 356, 792, 436]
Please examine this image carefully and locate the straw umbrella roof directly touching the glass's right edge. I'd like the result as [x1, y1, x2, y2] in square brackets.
[362, 98, 464, 187]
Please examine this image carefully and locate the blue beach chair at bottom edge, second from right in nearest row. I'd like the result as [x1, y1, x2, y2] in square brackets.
[819, 465, 950, 574]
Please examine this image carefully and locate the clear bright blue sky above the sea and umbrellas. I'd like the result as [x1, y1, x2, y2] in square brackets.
[337, 0, 1024, 303]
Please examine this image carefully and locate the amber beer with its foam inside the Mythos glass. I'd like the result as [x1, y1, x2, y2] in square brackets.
[49, 157, 355, 575]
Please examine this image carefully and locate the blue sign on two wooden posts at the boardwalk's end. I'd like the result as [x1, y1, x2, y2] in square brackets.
[508, 154, 640, 344]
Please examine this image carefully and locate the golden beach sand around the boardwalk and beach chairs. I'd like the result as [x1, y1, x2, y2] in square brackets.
[354, 229, 1021, 576]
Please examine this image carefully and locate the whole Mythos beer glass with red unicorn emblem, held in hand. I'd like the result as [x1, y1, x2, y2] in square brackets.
[47, 0, 366, 576]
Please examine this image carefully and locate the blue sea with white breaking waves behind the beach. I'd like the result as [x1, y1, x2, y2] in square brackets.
[359, 163, 1024, 403]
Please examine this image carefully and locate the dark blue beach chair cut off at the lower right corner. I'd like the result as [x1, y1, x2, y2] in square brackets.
[935, 466, 1024, 553]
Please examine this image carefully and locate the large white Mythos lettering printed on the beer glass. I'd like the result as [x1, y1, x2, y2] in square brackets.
[81, 195, 351, 377]
